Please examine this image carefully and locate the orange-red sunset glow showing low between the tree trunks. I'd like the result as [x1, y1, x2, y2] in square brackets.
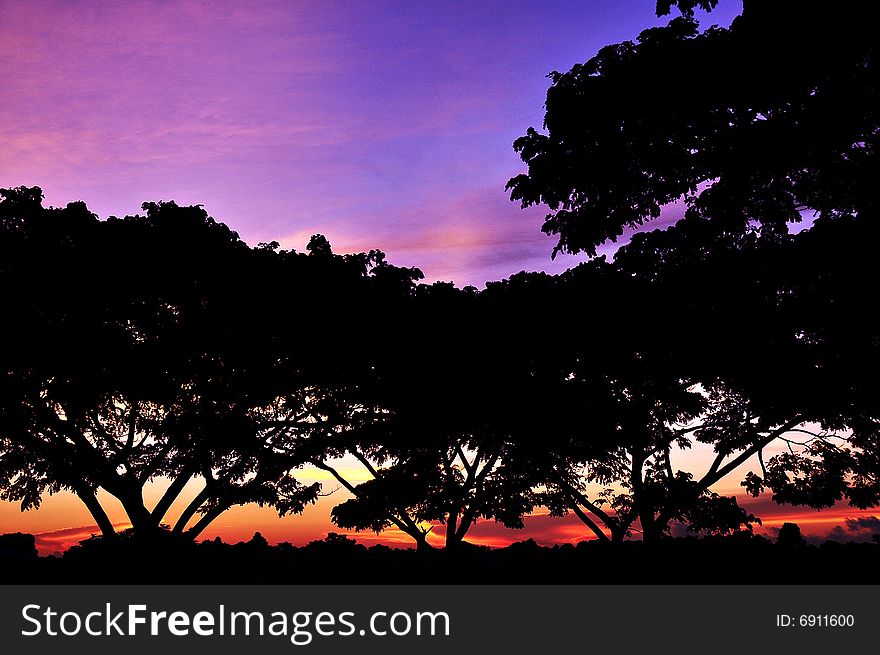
[0, 448, 880, 555]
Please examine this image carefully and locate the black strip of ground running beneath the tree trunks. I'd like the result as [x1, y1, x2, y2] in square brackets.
[0, 534, 880, 584]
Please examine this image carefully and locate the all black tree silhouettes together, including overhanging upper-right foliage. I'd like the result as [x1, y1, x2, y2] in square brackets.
[0, 0, 880, 550]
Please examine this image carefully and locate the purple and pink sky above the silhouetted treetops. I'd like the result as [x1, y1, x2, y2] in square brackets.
[0, 0, 741, 285]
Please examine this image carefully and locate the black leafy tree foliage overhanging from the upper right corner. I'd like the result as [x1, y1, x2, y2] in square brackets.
[507, 0, 880, 255]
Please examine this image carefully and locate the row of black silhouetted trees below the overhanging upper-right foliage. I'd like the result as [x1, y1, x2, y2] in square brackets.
[0, 188, 880, 548]
